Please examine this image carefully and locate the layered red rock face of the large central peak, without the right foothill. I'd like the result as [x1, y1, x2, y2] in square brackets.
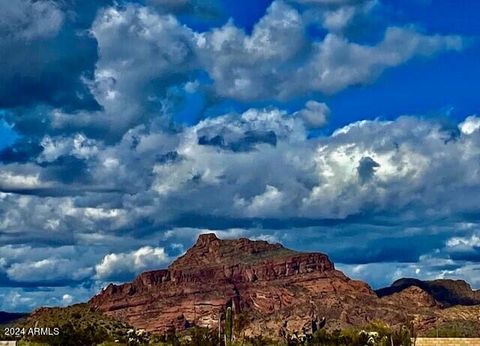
[90, 234, 376, 333]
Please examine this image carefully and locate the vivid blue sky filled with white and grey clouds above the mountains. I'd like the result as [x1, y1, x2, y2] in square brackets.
[0, 0, 480, 311]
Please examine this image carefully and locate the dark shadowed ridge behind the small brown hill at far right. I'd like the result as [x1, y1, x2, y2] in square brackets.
[376, 278, 480, 307]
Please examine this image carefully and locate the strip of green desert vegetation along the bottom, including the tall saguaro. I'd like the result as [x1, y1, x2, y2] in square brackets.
[0, 304, 479, 346]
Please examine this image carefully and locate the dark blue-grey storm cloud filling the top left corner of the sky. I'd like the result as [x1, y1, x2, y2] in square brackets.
[0, 0, 110, 110]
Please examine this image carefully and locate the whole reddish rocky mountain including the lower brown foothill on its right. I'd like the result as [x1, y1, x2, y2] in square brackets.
[89, 234, 480, 336]
